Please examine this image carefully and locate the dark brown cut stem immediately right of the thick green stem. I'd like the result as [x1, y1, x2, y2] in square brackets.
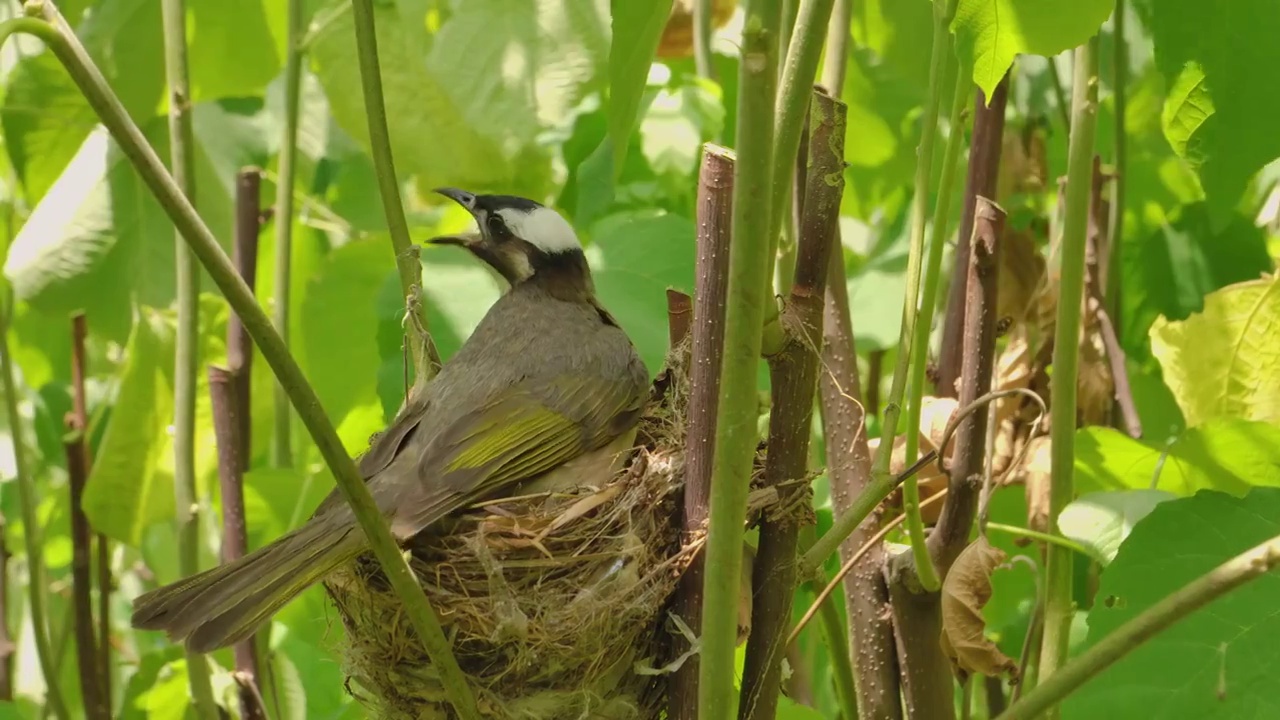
[741, 92, 846, 720]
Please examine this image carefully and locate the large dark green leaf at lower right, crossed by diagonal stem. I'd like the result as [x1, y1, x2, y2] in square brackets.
[1062, 488, 1280, 720]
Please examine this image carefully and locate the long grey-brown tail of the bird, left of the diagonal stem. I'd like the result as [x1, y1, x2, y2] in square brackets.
[132, 519, 366, 652]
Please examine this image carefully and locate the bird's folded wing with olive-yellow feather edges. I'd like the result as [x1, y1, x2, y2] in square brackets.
[394, 374, 639, 534]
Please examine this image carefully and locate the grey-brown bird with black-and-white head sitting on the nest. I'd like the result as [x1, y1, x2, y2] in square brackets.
[132, 187, 650, 653]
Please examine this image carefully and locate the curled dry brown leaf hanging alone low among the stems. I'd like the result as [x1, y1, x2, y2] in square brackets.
[942, 537, 1018, 679]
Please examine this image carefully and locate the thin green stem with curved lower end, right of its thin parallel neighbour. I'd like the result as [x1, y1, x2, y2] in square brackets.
[902, 63, 973, 592]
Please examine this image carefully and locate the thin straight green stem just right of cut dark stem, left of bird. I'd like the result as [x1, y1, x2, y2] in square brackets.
[271, 0, 303, 468]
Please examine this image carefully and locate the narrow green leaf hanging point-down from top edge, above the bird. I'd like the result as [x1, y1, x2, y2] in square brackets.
[608, 0, 672, 172]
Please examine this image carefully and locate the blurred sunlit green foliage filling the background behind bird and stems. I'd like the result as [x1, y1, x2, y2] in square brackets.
[0, 0, 1280, 719]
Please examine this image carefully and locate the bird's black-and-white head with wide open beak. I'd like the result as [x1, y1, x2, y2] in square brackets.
[429, 187, 593, 295]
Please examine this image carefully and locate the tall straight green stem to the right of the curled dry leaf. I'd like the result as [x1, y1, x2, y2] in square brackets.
[1039, 36, 1098, 696]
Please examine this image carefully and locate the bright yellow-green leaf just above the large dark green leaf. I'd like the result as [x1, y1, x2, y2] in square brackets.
[1075, 419, 1280, 496]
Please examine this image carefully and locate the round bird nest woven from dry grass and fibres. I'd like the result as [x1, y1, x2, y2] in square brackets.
[325, 351, 696, 720]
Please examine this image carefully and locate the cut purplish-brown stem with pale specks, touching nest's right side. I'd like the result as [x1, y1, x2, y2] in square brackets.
[667, 143, 733, 720]
